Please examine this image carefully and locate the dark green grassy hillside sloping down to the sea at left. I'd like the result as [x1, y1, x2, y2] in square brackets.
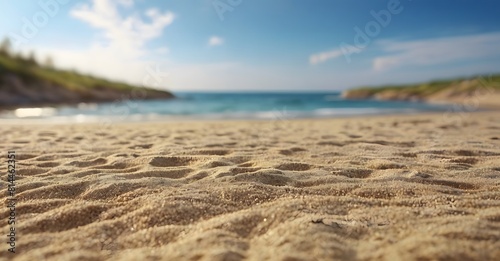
[0, 49, 173, 107]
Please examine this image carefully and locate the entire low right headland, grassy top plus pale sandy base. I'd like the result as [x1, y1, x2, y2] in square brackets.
[342, 75, 500, 108]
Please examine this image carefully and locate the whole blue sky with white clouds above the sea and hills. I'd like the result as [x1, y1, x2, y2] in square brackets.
[0, 0, 500, 91]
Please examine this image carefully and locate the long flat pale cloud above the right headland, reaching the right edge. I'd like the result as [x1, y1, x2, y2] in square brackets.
[373, 33, 500, 71]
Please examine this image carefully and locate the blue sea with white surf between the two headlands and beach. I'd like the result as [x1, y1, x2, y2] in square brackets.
[0, 92, 449, 121]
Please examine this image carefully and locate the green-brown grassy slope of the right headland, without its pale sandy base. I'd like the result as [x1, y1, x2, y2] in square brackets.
[343, 74, 500, 100]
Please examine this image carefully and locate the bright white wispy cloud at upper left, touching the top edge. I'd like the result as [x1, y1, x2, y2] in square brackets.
[71, 0, 174, 56]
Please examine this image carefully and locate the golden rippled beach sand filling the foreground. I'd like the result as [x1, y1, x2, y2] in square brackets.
[0, 112, 500, 261]
